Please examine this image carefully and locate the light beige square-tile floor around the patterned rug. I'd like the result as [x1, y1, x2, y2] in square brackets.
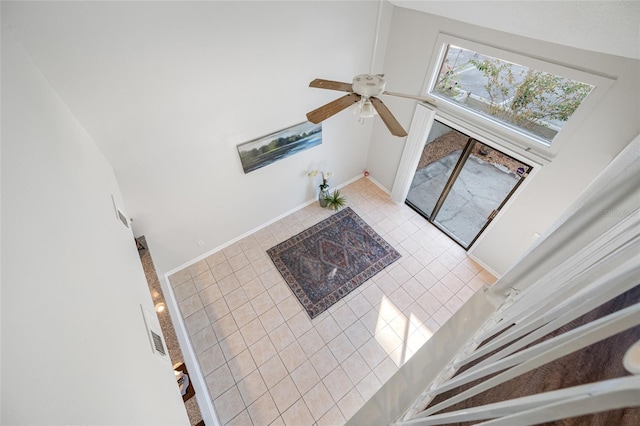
[170, 178, 495, 426]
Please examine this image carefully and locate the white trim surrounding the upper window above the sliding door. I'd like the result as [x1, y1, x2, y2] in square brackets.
[422, 33, 615, 162]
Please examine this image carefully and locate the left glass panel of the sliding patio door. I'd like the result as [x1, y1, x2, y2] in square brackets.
[406, 121, 469, 218]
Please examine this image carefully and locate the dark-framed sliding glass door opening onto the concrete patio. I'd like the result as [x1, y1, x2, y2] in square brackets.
[406, 120, 531, 249]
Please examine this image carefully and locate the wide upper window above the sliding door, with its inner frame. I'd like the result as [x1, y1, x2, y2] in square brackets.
[427, 35, 612, 157]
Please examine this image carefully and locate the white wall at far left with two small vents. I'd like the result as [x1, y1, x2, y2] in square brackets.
[1, 28, 188, 425]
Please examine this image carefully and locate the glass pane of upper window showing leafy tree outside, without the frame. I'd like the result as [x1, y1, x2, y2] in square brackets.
[431, 45, 594, 144]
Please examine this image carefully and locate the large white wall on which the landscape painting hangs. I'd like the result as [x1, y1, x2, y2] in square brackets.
[3, 1, 384, 274]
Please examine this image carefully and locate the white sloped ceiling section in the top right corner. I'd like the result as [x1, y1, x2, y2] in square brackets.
[389, 0, 640, 59]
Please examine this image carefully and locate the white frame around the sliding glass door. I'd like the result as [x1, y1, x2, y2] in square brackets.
[391, 103, 544, 252]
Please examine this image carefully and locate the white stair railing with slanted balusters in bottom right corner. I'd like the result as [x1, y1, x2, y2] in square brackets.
[393, 210, 640, 426]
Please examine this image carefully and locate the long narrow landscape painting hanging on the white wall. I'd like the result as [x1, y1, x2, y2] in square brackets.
[238, 121, 322, 173]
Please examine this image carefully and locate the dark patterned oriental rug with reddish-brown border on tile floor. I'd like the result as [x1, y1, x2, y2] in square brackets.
[267, 207, 400, 319]
